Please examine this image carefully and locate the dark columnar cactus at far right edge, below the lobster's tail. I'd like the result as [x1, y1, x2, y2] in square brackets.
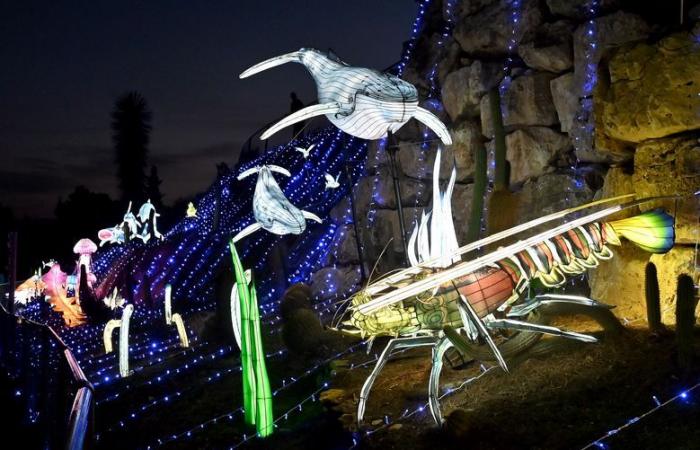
[676, 274, 697, 370]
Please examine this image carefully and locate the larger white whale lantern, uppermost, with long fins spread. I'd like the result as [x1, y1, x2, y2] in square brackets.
[240, 48, 452, 145]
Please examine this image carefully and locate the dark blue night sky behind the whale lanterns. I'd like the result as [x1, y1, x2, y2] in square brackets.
[0, 0, 416, 217]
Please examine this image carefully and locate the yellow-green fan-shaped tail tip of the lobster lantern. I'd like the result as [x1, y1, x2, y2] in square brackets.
[604, 209, 675, 253]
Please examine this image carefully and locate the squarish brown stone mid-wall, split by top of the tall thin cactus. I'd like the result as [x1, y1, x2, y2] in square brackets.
[481, 72, 558, 137]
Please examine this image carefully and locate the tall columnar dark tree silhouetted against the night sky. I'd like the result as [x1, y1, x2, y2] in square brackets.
[112, 92, 151, 204]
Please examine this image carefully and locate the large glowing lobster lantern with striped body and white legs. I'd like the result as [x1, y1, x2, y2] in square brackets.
[343, 184, 674, 423]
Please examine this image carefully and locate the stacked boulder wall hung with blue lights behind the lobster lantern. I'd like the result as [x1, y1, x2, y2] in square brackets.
[314, 0, 700, 321]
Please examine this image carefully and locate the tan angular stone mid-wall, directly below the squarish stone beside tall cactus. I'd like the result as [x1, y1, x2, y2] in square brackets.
[506, 127, 571, 184]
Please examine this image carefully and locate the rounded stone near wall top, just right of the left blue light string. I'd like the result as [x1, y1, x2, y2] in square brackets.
[518, 21, 574, 73]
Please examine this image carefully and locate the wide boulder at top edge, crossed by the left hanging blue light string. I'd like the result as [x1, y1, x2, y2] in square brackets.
[453, 0, 543, 55]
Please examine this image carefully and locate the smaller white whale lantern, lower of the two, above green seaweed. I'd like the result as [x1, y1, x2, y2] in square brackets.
[233, 165, 323, 243]
